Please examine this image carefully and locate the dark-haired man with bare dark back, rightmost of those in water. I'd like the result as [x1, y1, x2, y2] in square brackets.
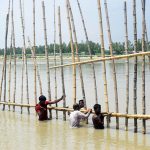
[92, 104, 104, 129]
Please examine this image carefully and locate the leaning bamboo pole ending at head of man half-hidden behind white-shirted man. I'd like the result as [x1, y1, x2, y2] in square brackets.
[68, 0, 87, 108]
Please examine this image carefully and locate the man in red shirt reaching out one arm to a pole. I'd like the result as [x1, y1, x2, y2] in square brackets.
[35, 95, 65, 121]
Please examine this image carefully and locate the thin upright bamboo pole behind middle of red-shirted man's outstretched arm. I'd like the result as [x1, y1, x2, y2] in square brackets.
[54, 0, 58, 119]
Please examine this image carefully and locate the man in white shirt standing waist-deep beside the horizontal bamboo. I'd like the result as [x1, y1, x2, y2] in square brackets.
[69, 103, 92, 128]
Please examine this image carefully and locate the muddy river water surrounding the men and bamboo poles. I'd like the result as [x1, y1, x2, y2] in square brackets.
[0, 59, 150, 150]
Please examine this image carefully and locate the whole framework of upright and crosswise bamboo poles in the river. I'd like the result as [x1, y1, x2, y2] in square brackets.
[0, 0, 150, 134]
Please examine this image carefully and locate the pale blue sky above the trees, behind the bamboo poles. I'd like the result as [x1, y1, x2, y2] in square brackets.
[0, 0, 150, 48]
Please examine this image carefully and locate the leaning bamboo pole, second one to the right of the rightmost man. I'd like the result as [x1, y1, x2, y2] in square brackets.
[104, 0, 119, 129]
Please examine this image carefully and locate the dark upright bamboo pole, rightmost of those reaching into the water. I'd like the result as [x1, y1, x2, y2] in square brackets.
[142, 0, 146, 134]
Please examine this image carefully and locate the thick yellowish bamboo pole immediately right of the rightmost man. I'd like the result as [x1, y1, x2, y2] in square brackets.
[97, 0, 109, 127]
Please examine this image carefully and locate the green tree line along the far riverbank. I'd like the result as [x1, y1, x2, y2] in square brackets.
[0, 39, 150, 55]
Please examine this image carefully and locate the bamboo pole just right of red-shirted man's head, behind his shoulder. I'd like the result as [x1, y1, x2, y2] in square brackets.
[42, 1, 52, 119]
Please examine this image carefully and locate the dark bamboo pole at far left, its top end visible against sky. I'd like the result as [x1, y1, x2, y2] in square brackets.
[3, 14, 9, 110]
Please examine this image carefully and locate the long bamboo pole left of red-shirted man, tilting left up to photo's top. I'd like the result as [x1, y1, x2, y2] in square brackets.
[20, 0, 30, 114]
